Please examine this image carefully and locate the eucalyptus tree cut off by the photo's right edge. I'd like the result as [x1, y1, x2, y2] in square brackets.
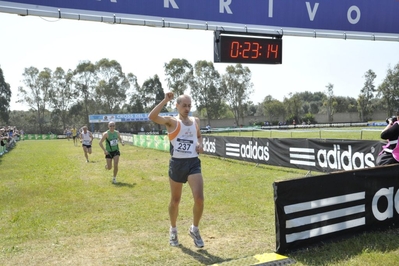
[377, 63, 399, 116]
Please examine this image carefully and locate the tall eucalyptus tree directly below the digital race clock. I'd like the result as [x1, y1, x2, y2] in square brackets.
[222, 64, 253, 125]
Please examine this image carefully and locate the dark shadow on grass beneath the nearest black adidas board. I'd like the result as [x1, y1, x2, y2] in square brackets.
[287, 228, 399, 266]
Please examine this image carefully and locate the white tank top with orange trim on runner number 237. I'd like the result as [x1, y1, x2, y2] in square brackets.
[168, 117, 198, 158]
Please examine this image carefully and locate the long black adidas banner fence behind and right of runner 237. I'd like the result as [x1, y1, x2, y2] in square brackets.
[203, 135, 384, 173]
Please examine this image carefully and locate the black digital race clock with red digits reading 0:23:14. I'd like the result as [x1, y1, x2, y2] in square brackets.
[214, 30, 283, 64]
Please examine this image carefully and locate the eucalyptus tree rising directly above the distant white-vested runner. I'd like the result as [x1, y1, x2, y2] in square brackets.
[70, 61, 97, 123]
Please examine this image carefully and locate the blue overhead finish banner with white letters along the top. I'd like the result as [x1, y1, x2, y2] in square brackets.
[0, 0, 399, 34]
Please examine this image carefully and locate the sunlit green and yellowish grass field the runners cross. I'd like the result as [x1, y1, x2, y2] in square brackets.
[0, 136, 399, 265]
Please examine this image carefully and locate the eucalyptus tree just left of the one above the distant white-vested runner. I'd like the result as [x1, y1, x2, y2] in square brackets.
[50, 67, 78, 128]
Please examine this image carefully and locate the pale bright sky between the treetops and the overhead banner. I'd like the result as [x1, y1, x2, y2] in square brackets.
[0, 13, 399, 110]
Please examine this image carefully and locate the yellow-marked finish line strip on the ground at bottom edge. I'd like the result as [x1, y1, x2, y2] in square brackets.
[212, 253, 295, 266]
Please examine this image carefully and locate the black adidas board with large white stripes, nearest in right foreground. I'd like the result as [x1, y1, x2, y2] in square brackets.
[273, 165, 399, 254]
